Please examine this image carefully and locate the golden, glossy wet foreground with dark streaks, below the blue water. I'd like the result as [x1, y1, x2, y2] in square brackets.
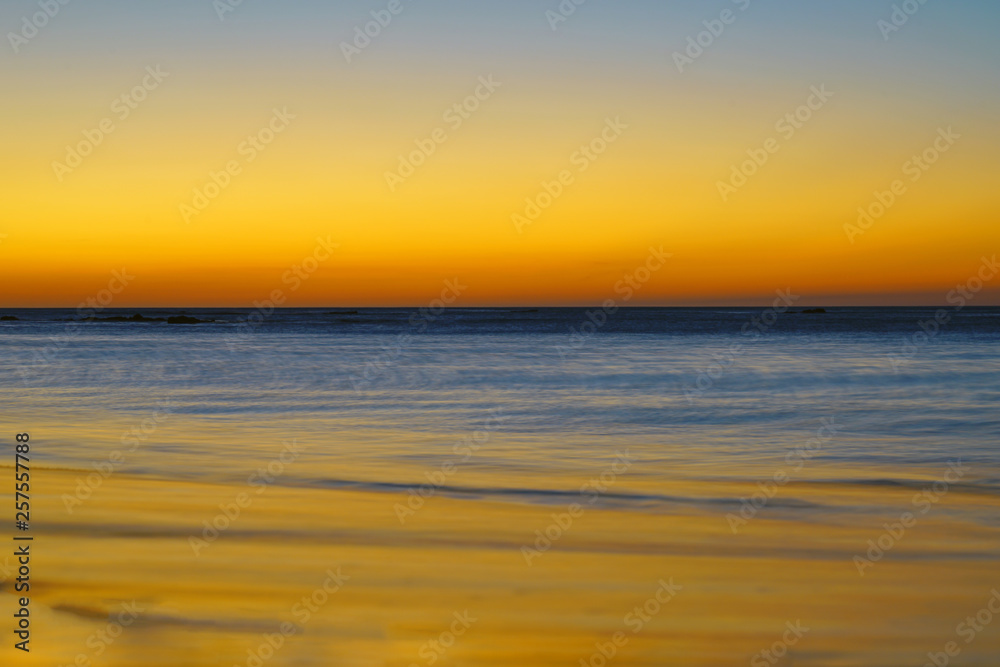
[0, 468, 1000, 667]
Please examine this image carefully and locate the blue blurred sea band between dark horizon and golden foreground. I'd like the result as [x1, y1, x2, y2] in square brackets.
[0, 308, 1000, 489]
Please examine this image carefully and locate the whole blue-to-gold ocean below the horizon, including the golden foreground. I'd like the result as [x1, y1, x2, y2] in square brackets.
[0, 305, 1000, 667]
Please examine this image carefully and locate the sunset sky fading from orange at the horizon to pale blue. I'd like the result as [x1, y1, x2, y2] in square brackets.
[0, 0, 1000, 307]
